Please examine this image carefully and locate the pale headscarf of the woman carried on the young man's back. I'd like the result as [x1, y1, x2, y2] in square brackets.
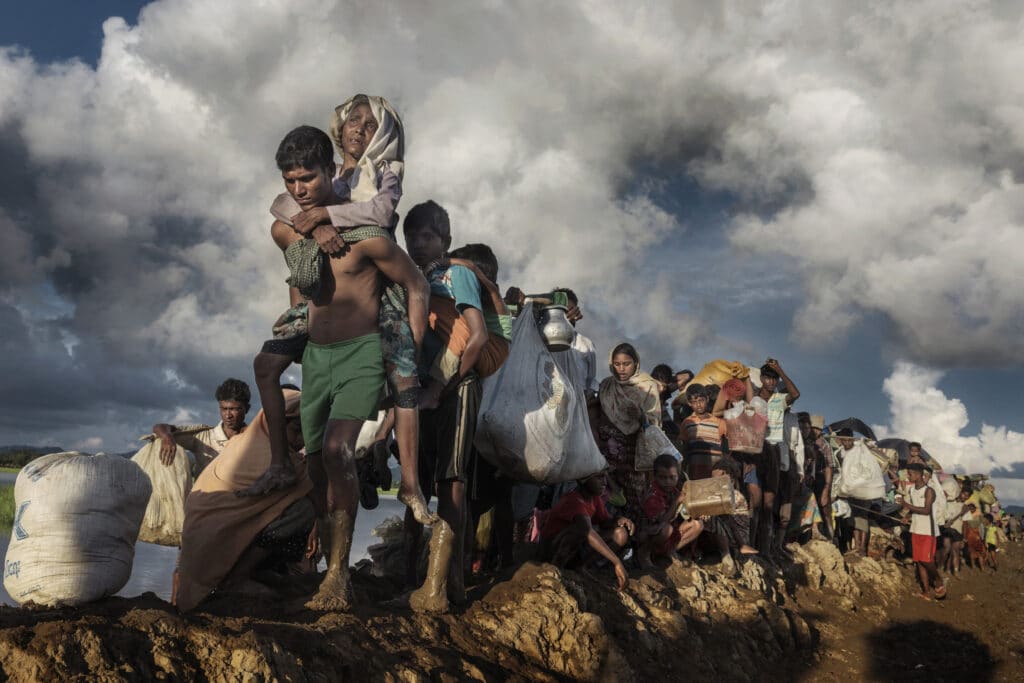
[331, 95, 406, 202]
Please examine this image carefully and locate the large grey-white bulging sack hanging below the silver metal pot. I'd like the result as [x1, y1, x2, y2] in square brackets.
[475, 304, 607, 483]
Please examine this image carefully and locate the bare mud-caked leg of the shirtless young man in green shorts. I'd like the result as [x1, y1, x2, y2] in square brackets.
[306, 420, 362, 611]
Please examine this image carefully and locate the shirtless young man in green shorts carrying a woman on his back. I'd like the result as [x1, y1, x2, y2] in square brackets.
[271, 126, 429, 610]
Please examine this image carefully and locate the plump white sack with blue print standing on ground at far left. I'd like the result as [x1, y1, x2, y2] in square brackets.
[3, 453, 152, 606]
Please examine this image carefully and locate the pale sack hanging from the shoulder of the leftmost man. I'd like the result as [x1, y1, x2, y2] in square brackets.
[131, 439, 193, 547]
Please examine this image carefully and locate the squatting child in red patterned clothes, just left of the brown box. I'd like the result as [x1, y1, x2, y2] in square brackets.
[637, 453, 703, 569]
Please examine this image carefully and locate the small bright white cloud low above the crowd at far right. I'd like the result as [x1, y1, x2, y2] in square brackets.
[876, 361, 1024, 485]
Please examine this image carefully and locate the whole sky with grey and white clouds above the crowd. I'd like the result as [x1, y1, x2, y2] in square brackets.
[0, 0, 1024, 500]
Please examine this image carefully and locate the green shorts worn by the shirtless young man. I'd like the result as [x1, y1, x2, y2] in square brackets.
[300, 334, 384, 453]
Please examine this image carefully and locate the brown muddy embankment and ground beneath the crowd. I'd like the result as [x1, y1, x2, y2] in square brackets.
[0, 542, 1024, 682]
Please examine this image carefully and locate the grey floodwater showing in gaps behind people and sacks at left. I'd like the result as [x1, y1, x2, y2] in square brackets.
[0, 493, 406, 605]
